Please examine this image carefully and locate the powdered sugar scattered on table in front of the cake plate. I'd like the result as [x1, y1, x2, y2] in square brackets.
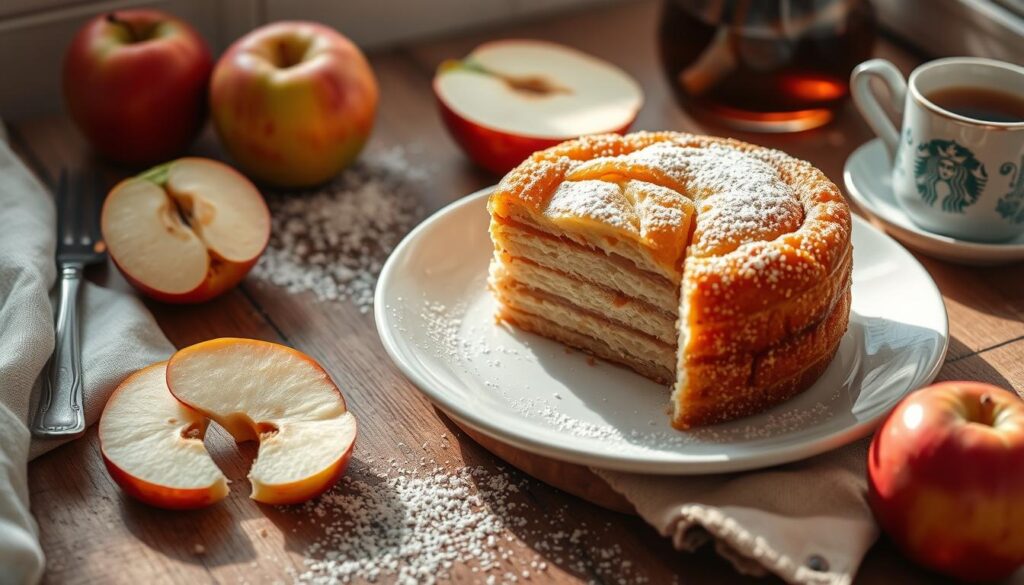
[295, 463, 648, 585]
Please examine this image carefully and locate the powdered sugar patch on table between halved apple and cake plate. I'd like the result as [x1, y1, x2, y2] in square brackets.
[252, 149, 426, 312]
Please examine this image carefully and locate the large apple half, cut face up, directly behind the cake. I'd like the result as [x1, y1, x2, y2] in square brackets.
[434, 40, 643, 174]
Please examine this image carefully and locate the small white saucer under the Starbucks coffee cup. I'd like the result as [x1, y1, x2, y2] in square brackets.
[843, 138, 1024, 266]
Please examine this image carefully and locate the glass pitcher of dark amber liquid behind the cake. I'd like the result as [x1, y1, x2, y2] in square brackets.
[659, 0, 874, 132]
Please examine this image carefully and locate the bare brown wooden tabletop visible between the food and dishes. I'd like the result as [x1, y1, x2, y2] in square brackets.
[10, 1, 1024, 584]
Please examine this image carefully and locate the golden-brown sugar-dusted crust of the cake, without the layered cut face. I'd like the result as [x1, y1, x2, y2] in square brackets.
[488, 132, 852, 428]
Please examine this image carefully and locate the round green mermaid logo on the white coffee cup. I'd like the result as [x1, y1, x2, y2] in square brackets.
[913, 139, 988, 213]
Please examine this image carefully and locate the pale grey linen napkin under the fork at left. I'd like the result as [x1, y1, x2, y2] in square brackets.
[0, 135, 174, 585]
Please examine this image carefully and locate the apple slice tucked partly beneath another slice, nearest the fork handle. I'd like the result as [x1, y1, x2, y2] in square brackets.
[99, 362, 227, 509]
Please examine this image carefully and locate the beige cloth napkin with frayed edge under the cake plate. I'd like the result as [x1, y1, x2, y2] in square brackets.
[593, 440, 879, 585]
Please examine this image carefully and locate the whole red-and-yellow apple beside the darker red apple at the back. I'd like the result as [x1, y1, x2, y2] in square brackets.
[210, 22, 378, 186]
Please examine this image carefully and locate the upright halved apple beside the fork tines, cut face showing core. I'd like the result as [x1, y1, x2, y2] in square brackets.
[100, 158, 270, 302]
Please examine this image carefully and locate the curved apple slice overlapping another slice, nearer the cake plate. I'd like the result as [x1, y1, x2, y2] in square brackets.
[167, 338, 355, 504]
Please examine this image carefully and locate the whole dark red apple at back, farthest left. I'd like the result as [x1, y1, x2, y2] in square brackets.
[63, 9, 213, 165]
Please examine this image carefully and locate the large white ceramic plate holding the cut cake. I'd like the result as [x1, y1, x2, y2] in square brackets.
[375, 190, 947, 474]
